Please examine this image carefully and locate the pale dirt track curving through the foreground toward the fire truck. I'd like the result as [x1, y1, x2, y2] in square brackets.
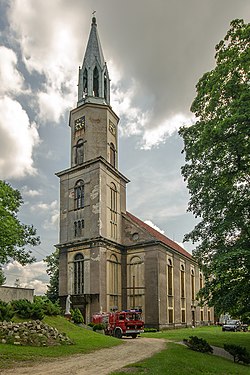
[0, 337, 166, 375]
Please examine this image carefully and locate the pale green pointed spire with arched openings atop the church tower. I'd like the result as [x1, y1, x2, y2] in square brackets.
[77, 16, 110, 107]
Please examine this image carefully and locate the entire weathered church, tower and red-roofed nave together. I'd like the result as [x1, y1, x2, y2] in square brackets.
[56, 17, 214, 329]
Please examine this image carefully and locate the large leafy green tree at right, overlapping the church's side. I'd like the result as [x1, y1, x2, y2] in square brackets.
[179, 20, 250, 316]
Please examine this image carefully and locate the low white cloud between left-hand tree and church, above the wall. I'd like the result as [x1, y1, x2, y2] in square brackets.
[4, 261, 49, 295]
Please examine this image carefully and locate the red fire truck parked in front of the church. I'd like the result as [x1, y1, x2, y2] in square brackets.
[92, 310, 144, 339]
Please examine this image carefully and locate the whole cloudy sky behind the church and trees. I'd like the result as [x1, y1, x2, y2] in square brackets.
[0, 0, 250, 294]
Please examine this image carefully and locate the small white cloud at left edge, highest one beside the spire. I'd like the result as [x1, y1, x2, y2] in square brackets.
[0, 46, 24, 95]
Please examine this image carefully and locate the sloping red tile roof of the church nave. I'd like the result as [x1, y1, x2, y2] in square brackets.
[126, 211, 192, 258]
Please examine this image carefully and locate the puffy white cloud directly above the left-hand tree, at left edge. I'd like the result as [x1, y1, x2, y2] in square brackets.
[0, 97, 39, 179]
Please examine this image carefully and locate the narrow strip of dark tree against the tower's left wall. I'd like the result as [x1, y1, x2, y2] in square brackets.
[44, 249, 59, 303]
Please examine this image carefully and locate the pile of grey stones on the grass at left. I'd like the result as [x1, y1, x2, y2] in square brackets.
[0, 320, 73, 346]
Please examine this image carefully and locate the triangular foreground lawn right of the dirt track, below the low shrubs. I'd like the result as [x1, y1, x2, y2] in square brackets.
[112, 343, 250, 375]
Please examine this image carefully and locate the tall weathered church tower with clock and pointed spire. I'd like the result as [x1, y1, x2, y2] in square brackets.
[57, 17, 128, 322]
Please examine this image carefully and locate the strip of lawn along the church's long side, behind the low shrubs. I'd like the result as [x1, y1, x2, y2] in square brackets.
[144, 326, 250, 352]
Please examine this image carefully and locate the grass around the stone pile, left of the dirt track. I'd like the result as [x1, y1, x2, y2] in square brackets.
[0, 316, 122, 369]
